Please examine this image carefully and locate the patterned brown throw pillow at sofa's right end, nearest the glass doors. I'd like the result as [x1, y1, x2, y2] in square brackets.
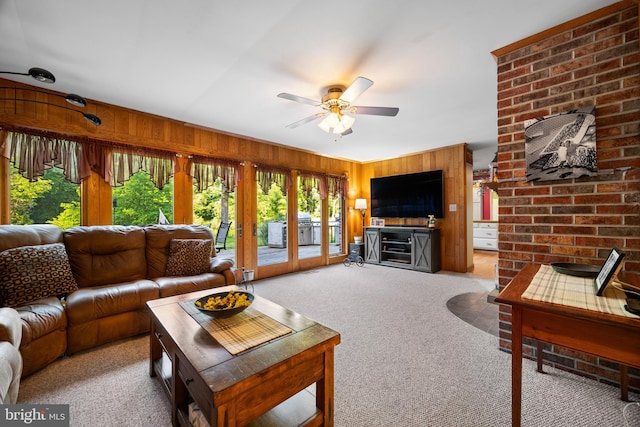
[165, 239, 212, 276]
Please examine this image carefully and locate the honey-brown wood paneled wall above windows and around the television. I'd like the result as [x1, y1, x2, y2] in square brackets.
[0, 79, 473, 272]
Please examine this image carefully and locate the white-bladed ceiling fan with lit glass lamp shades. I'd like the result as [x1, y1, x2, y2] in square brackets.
[278, 77, 400, 136]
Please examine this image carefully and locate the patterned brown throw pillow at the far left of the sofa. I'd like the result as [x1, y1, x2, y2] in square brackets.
[0, 243, 78, 307]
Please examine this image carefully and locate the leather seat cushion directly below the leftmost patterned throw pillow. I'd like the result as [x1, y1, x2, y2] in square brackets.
[16, 297, 67, 347]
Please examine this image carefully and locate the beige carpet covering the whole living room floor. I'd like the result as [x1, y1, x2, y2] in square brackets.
[20, 264, 640, 427]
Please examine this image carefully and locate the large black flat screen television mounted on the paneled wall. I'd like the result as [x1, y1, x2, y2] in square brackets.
[371, 170, 444, 218]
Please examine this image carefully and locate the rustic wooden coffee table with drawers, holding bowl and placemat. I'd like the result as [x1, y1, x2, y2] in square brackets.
[147, 286, 340, 427]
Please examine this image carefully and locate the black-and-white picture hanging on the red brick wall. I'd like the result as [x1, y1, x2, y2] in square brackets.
[524, 106, 598, 181]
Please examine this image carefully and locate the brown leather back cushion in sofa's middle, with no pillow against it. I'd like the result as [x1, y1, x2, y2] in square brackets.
[64, 225, 147, 288]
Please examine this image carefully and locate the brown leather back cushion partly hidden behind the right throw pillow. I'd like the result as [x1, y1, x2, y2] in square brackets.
[145, 224, 215, 279]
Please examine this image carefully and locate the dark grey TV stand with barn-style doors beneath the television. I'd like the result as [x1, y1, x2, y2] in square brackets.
[364, 227, 440, 273]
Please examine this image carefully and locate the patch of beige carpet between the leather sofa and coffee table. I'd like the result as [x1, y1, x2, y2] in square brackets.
[18, 336, 171, 427]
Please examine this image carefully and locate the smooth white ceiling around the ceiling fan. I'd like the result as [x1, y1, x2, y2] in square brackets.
[0, 0, 615, 169]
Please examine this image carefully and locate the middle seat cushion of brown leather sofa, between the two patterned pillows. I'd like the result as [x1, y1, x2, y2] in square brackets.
[66, 279, 160, 325]
